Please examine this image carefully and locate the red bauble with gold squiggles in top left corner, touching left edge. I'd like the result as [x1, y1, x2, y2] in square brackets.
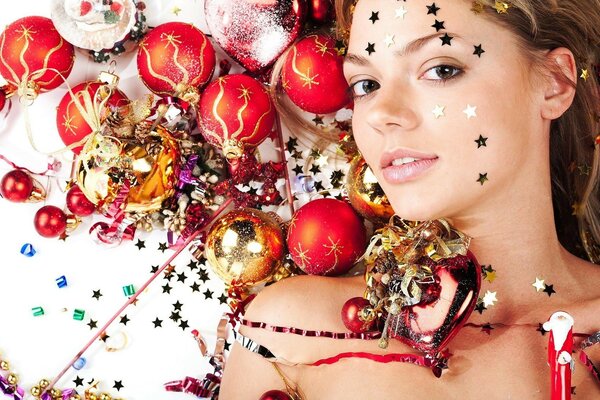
[0, 16, 75, 96]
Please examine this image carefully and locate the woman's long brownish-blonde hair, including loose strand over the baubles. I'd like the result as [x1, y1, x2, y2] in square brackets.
[272, 0, 600, 263]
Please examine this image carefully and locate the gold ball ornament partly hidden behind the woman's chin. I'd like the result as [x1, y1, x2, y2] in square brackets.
[346, 155, 394, 222]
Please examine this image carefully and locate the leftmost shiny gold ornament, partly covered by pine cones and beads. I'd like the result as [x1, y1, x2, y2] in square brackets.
[77, 125, 179, 213]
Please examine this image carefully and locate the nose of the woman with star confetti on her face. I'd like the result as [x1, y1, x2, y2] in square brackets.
[366, 88, 419, 134]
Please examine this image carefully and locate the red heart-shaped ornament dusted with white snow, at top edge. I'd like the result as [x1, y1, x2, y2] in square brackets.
[204, 0, 307, 72]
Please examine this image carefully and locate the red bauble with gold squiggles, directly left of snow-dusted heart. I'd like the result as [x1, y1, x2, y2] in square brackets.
[137, 22, 216, 103]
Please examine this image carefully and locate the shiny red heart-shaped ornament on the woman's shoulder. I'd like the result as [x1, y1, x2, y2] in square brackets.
[388, 252, 481, 356]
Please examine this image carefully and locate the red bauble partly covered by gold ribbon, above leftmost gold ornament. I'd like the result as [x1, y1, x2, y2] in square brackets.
[56, 81, 129, 154]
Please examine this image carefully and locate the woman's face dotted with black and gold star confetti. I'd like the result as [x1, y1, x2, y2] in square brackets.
[344, 0, 546, 220]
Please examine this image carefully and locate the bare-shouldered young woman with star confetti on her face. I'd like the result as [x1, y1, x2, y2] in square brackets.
[220, 0, 600, 400]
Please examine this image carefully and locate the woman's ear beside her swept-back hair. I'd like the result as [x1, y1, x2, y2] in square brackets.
[541, 47, 577, 120]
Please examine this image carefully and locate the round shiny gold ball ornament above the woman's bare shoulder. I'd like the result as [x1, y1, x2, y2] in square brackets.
[205, 208, 285, 286]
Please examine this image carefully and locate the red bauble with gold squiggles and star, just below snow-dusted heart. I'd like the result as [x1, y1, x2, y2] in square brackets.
[198, 74, 276, 158]
